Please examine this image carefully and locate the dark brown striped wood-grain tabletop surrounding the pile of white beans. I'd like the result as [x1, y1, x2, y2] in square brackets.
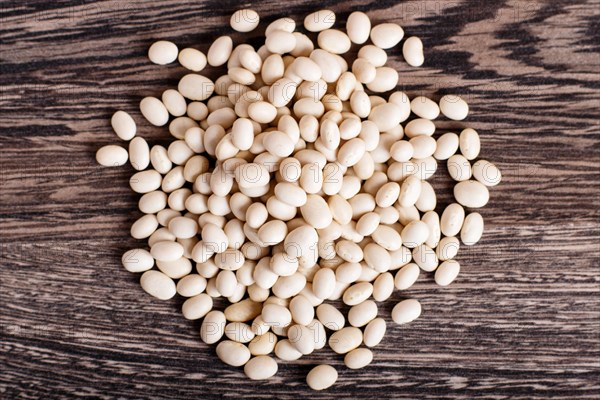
[0, 0, 600, 399]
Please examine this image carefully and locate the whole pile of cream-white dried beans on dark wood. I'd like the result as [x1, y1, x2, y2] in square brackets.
[96, 9, 500, 390]
